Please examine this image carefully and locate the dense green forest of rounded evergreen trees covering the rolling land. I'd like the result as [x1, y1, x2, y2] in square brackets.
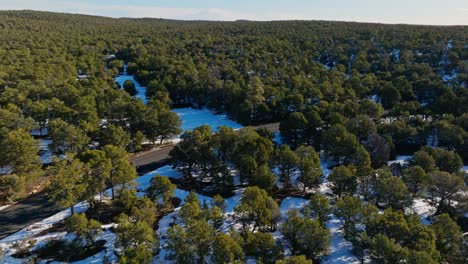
[0, 11, 468, 264]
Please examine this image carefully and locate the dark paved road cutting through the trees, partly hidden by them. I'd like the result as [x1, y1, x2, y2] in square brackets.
[0, 123, 279, 239]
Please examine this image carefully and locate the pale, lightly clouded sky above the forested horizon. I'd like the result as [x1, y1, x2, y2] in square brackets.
[0, 0, 468, 25]
